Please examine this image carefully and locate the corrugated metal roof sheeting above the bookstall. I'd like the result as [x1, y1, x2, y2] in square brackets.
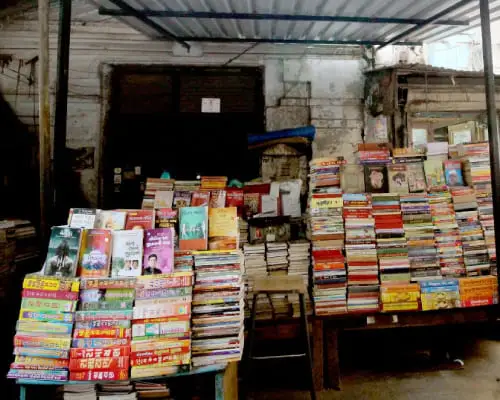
[89, 0, 500, 42]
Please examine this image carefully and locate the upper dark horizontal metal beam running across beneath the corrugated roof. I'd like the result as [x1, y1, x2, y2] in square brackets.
[99, 7, 469, 26]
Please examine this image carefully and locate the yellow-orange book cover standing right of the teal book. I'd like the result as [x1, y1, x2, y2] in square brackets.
[208, 207, 240, 250]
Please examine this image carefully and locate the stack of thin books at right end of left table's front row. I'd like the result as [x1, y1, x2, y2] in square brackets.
[192, 250, 244, 367]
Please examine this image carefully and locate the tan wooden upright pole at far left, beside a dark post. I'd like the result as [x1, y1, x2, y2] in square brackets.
[38, 0, 53, 241]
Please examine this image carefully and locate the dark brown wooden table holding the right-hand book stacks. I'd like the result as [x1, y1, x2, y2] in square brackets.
[312, 306, 497, 391]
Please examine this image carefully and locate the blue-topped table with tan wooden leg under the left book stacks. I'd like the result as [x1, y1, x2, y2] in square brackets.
[17, 362, 238, 400]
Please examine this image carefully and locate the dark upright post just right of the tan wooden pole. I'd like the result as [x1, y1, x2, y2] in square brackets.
[54, 0, 71, 223]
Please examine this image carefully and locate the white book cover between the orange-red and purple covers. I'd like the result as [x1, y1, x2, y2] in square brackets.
[111, 229, 144, 277]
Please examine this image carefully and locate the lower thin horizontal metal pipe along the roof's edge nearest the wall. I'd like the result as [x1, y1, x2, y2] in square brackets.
[172, 36, 422, 46]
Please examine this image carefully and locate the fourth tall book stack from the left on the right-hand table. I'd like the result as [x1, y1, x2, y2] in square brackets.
[400, 193, 441, 282]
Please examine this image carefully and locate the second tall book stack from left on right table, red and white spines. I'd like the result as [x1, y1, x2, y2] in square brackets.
[343, 193, 379, 286]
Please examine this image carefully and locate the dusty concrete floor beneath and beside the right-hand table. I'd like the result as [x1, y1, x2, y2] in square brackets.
[249, 331, 500, 400]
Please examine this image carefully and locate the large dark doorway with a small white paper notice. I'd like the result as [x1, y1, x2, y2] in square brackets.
[102, 66, 265, 208]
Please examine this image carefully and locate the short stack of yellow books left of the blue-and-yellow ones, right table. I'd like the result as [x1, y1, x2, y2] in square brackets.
[380, 283, 420, 312]
